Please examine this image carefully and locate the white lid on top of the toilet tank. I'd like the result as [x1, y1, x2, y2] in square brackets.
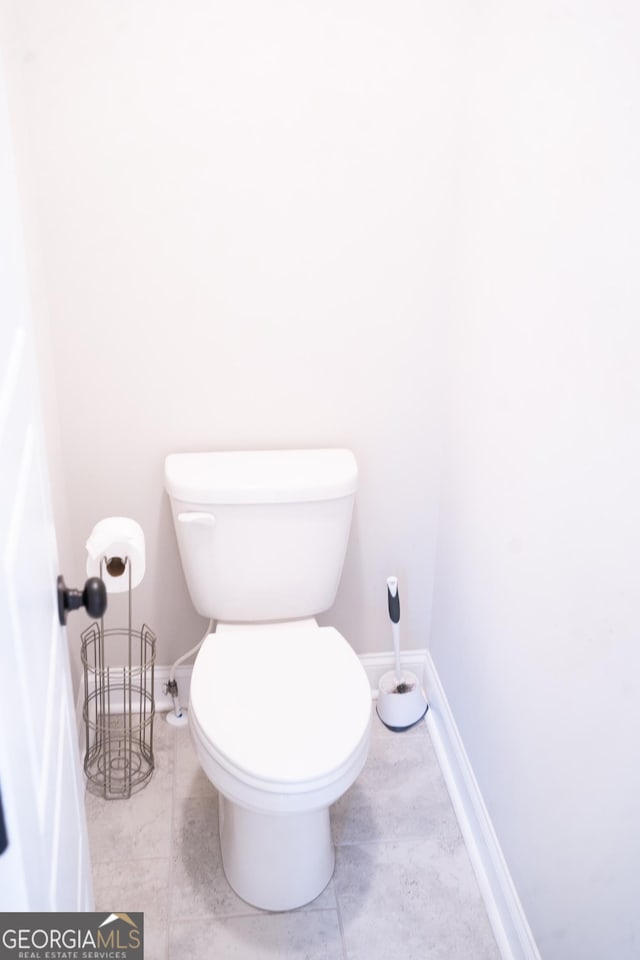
[164, 448, 358, 503]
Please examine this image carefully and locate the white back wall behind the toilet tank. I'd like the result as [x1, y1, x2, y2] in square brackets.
[1, 0, 452, 663]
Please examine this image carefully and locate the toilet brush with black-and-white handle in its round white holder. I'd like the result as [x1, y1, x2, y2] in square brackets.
[376, 577, 429, 731]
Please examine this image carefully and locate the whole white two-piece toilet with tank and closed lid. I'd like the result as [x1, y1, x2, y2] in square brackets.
[165, 449, 371, 910]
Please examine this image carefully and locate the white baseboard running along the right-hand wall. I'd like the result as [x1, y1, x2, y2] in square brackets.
[424, 654, 540, 960]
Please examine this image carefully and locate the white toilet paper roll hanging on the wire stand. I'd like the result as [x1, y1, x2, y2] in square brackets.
[86, 517, 145, 593]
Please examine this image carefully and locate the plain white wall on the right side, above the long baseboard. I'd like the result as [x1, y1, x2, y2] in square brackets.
[431, 2, 640, 960]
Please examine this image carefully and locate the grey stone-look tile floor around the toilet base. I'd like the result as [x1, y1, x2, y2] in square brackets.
[86, 700, 500, 960]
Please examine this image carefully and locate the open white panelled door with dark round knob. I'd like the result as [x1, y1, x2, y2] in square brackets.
[0, 50, 93, 911]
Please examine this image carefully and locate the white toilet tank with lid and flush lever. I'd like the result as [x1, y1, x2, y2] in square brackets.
[165, 449, 358, 623]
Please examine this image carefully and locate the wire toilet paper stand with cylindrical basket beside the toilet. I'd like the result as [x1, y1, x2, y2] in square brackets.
[81, 557, 156, 800]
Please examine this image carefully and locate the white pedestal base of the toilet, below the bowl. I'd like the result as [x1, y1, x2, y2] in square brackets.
[218, 793, 335, 910]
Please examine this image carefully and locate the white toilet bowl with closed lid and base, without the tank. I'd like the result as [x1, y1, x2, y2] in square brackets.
[189, 620, 371, 910]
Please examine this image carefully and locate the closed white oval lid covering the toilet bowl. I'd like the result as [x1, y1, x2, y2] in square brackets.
[190, 624, 371, 786]
